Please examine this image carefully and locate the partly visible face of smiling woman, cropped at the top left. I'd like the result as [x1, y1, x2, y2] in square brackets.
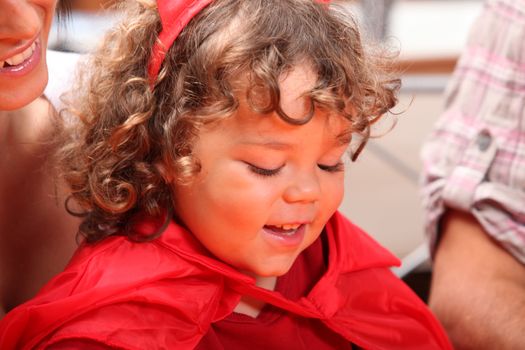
[0, 0, 57, 110]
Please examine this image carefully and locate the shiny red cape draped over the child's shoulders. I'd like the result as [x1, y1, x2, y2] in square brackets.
[0, 213, 452, 350]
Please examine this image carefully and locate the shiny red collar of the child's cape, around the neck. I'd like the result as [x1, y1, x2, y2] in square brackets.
[145, 212, 400, 318]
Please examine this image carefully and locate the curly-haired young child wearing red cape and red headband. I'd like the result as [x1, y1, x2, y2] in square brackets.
[0, 0, 450, 349]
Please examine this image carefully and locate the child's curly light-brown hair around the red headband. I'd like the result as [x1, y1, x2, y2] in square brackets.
[60, 0, 400, 242]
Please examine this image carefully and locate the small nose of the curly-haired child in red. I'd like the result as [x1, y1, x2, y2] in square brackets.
[284, 171, 321, 203]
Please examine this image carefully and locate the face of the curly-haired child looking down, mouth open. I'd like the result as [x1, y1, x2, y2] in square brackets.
[174, 66, 349, 277]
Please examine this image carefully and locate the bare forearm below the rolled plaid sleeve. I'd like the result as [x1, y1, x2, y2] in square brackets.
[429, 210, 525, 350]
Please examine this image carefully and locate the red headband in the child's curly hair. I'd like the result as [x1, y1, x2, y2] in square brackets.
[148, 0, 330, 88]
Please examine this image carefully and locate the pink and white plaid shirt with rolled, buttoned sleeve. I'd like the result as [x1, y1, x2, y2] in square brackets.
[422, 0, 525, 263]
